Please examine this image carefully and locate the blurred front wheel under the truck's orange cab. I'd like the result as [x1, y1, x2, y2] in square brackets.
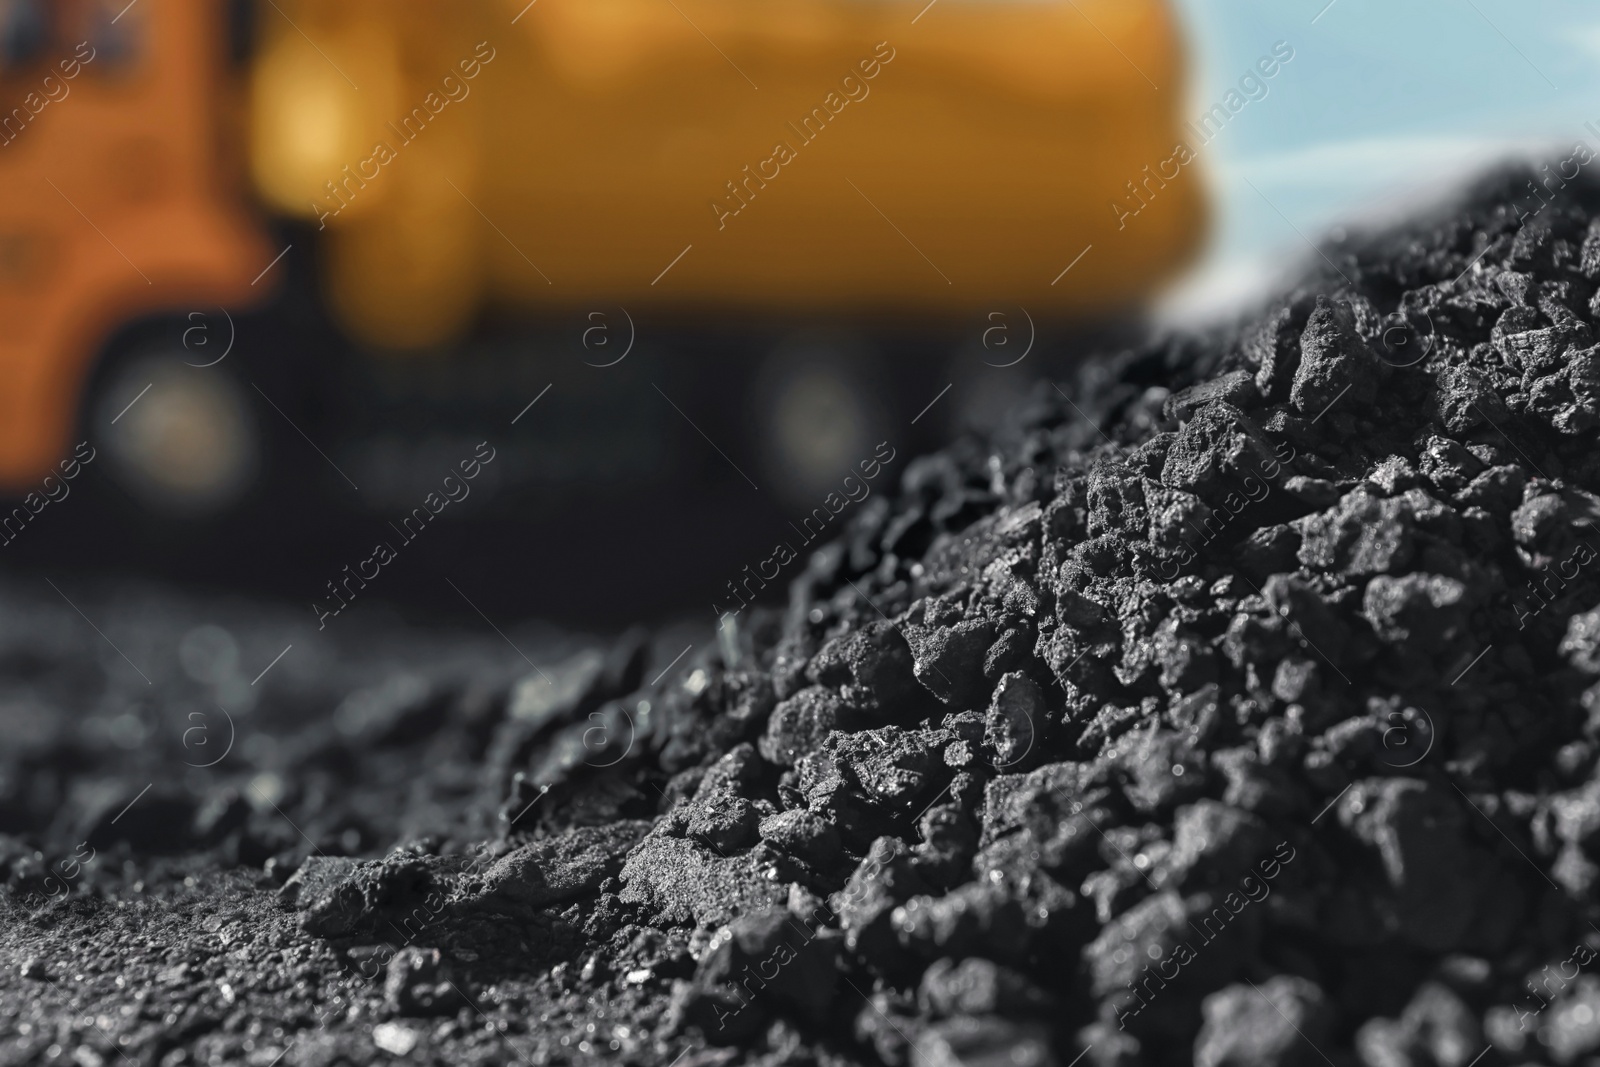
[90, 347, 264, 522]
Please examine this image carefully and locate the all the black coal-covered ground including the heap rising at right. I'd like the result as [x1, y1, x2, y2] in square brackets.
[9, 167, 1600, 1067]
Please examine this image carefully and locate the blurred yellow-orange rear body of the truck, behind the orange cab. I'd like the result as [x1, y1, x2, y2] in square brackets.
[251, 0, 1203, 346]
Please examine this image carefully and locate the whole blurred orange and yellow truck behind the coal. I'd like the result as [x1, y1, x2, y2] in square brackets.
[0, 0, 1205, 518]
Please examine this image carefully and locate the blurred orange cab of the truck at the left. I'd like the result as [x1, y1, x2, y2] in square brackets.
[0, 0, 274, 508]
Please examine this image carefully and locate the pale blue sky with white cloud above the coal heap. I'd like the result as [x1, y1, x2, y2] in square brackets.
[1170, 0, 1600, 312]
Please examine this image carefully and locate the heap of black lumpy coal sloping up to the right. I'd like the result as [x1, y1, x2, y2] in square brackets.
[15, 167, 1600, 1067]
